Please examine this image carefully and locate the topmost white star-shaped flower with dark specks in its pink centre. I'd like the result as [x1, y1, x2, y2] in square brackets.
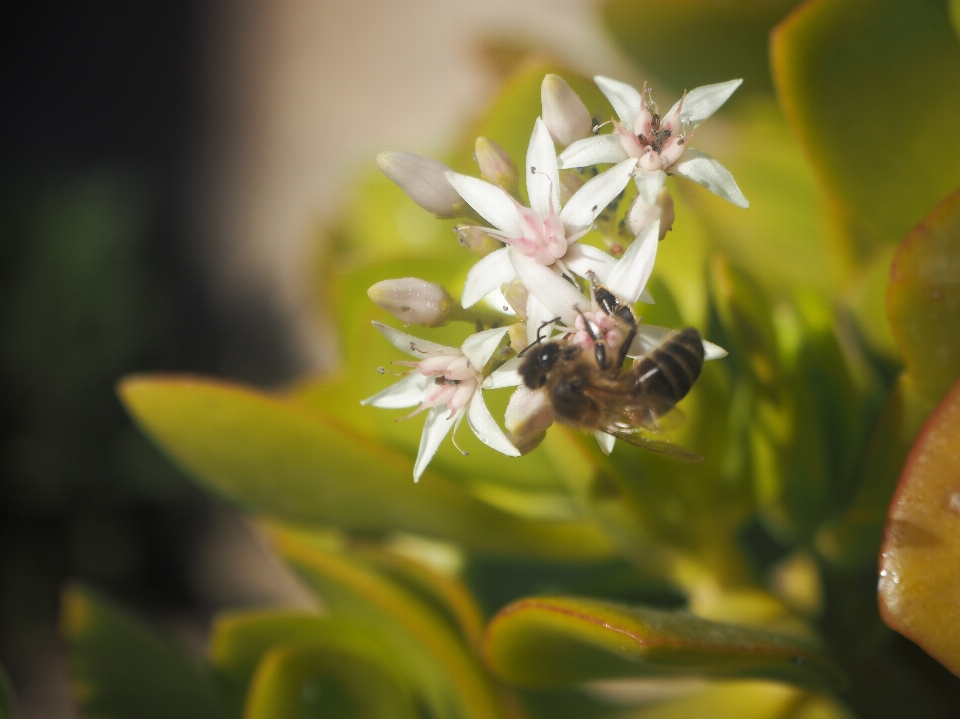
[560, 76, 750, 207]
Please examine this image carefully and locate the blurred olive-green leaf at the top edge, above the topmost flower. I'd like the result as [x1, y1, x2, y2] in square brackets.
[602, 0, 798, 97]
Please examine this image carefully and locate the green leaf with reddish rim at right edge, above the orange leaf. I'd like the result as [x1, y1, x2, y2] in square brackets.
[887, 190, 960, 403]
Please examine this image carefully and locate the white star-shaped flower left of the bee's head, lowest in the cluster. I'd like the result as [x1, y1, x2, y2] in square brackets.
[361, 322, 520, 481]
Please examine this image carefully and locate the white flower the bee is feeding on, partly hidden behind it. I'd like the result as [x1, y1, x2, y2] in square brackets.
[483, 221, 727, 454]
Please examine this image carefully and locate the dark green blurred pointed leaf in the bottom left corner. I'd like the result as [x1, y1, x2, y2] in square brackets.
[61, 586, 227, 719]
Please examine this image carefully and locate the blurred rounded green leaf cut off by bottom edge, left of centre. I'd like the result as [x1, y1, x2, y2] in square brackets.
[243, 643, 418, 719]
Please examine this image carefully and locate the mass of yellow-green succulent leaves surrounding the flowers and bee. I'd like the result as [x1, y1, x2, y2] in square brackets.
[68, 0, 960, 719]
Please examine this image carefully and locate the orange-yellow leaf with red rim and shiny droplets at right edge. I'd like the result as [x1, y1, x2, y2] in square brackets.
[880, 383, 960, 676]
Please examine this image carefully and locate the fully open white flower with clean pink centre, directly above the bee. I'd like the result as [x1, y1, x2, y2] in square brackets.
[447, 118, 637, 316]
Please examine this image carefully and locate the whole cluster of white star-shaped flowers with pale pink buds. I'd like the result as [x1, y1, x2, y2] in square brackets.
[364, 75, 747, 480]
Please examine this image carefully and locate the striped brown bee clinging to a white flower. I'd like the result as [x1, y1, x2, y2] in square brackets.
[519, 281, 704, 462]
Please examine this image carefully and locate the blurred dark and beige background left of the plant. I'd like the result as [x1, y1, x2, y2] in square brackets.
[0, 0, 635, 718]
